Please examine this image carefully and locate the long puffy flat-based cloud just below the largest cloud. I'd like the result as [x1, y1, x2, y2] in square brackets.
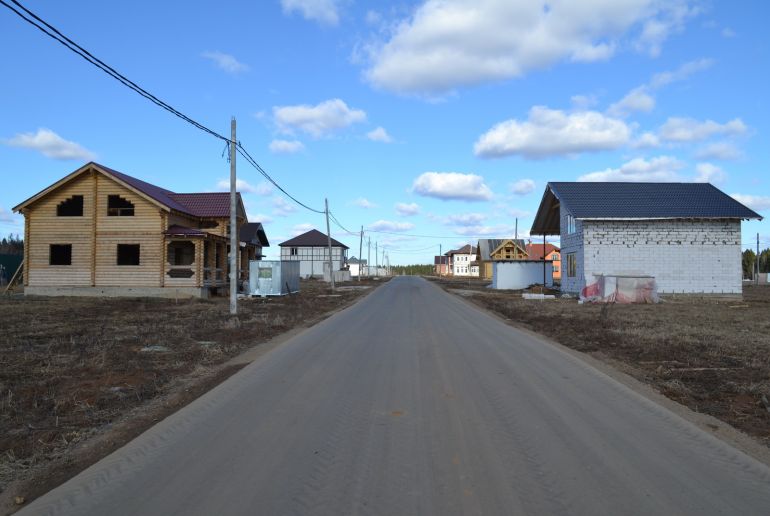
[474, 106, 631, 159]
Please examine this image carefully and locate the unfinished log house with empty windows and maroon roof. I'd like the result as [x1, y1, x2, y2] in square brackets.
[14, 162, 267, 297]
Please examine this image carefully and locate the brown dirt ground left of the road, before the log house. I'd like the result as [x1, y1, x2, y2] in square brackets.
[0, 280, 382, 513]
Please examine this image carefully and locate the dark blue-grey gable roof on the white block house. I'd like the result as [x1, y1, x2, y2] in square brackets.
[531, 182, 762, 235]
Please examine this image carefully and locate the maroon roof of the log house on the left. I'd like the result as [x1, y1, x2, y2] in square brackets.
[13, 161, 246, 217]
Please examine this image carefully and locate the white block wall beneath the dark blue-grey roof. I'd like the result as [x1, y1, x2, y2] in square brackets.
[584, 219, 742, 294]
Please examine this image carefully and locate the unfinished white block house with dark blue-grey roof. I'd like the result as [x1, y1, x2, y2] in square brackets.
[531, 182, 762, 294]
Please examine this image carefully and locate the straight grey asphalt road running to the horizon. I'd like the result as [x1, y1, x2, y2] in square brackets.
[20, 277, 770, 516]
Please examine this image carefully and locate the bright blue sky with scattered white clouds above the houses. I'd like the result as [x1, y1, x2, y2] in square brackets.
[0, 0, 770, 263]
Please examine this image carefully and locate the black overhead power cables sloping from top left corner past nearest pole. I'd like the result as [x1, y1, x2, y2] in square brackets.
[0, 0, 324, 213]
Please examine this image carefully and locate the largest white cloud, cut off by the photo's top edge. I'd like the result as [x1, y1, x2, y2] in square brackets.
[365, 0, 692, 96]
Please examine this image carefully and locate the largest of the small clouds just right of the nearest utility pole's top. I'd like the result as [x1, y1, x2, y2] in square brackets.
[273, 99, 366, 138]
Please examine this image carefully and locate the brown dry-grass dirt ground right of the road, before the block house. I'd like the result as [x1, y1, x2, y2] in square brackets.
[434, 280, 770, 446]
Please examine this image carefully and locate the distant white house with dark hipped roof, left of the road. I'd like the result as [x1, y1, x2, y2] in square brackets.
[279, 229, 349, 278]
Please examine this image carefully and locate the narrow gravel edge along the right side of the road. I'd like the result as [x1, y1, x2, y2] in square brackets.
[436, 282, 770, 466]
